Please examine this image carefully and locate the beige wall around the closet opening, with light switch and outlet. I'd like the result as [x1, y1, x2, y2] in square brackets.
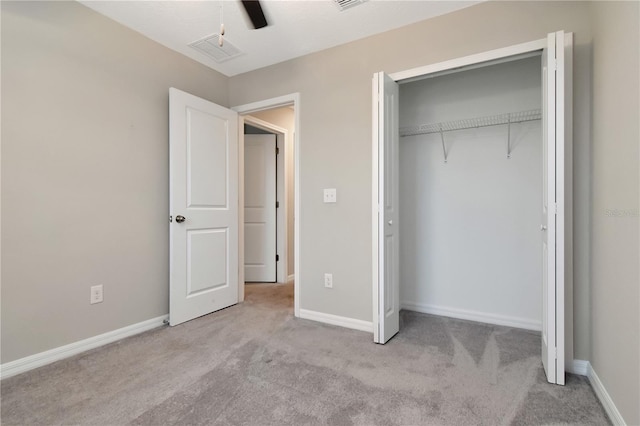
[229, 2, 591, 359]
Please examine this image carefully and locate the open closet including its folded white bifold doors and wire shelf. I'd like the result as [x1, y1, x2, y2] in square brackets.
[372, 31, 573, 384]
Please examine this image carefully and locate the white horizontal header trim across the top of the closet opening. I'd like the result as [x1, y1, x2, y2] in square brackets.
[390, 38, 547, 82]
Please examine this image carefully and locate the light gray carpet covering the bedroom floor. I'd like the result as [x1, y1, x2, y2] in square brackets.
[1, 284, 609, 425]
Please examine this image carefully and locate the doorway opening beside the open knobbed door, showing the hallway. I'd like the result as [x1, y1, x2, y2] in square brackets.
[244, 116, 294, 284]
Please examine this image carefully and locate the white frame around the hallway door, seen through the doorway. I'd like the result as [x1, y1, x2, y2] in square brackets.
[243, 115, 293, 283]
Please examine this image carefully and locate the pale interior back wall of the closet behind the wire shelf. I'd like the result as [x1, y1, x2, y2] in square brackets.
[399, 56, 543, 330]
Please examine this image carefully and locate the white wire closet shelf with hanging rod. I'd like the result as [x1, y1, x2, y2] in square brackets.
[400, 109, 542, 137]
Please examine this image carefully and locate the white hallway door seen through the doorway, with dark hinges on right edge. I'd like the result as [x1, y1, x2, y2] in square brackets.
[244, 135, 276, 282]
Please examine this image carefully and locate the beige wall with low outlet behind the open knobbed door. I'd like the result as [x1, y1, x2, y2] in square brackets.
[1, 1, 227, 363]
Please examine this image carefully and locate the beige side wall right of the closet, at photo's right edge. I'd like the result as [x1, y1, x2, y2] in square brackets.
[591, 2, 640, 425]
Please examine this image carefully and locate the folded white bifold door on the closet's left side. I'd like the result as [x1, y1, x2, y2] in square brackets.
[373, 72, 400, 343]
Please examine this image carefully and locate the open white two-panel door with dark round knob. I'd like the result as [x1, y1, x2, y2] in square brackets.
[169, 88, 238, 325]
